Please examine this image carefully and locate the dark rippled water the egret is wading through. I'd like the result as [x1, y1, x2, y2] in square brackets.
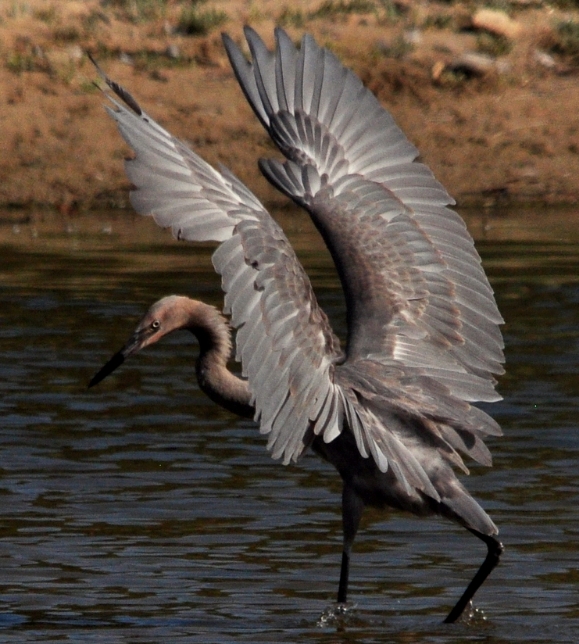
[0, 210, 579, 644]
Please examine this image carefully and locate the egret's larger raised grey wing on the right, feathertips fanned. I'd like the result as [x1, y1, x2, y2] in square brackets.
[224, 28, 503, 408]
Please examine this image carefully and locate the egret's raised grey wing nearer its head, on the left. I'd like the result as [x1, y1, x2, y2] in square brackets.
[97, 59, 343, 463]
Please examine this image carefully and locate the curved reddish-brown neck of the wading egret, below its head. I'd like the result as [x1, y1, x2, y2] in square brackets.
[182, 300, 255, 418]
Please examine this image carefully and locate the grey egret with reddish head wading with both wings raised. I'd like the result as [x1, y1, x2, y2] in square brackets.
[89, 27, 504, 623]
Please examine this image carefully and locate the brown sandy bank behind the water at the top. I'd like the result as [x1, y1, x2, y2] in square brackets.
[0, 0, 579, 212]
